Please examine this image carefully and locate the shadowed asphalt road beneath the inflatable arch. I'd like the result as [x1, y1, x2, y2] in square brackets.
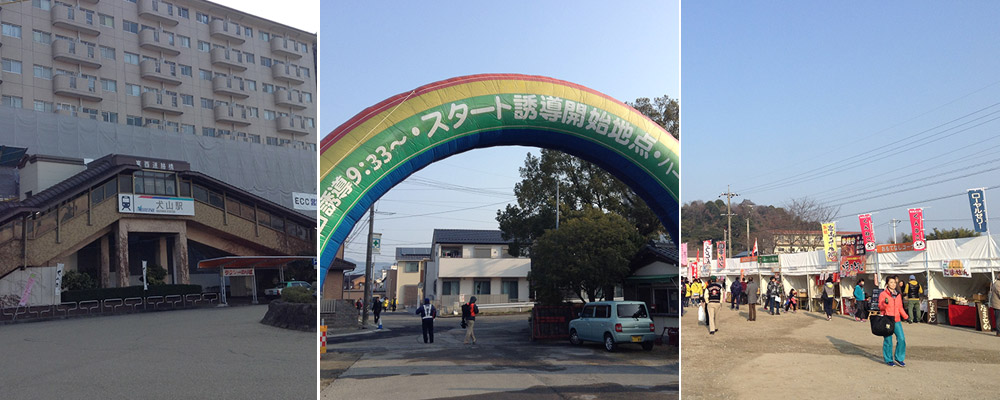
[320, 312, 678, 400]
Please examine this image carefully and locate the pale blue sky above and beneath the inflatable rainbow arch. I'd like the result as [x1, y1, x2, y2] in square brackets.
[319, 1, 680, 262]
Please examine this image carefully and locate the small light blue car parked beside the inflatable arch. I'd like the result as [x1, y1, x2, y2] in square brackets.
[569, 301, 656, 351]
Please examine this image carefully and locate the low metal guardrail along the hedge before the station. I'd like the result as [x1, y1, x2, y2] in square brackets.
[0, 293, 227, 323]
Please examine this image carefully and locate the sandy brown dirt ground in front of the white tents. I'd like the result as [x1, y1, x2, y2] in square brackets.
[681, 305, 1000, 399]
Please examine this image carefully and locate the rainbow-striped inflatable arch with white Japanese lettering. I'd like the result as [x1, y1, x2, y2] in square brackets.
[318, 74, 680, 285]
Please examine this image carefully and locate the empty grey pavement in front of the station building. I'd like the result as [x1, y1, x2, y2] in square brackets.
[0, 305, 317, 399]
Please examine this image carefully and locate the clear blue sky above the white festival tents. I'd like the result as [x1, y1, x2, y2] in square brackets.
[681, 1, 1000, 241]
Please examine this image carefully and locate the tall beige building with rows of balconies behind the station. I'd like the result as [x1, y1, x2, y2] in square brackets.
[0, 0, 317, 202]
